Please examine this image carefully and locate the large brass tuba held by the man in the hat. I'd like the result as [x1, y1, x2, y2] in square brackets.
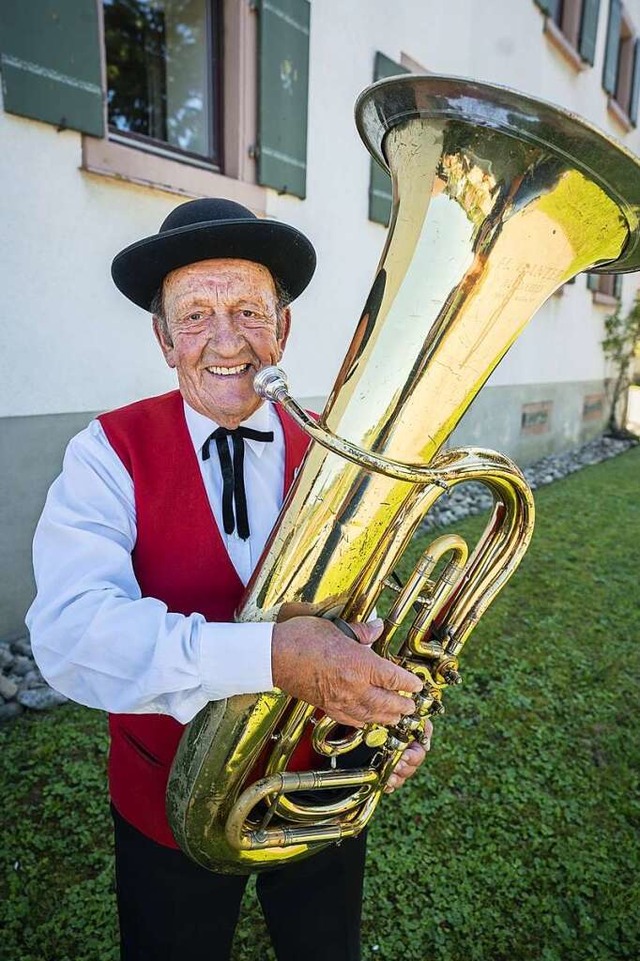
[167, 75, 640, 874]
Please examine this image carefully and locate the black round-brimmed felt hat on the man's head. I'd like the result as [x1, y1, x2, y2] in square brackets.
[111, 197, 316, 310]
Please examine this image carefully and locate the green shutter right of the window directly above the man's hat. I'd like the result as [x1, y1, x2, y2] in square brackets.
[258, 0, 310, 198]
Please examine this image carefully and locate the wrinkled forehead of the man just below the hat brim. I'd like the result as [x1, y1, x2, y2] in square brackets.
[163, 258, 276, 303]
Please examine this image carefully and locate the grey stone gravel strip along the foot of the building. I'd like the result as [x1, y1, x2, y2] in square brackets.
[0, 437, 638, 723]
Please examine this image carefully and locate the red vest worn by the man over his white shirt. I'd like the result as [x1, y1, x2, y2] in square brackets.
[99, 391, 309, 847]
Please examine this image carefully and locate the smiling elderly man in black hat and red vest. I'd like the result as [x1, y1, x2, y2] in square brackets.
[27, 200, 424, 961]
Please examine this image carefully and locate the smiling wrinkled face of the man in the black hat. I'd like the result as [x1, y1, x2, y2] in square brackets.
[154, 260, 290, 429]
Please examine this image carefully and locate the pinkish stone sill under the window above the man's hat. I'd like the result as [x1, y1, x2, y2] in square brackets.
[82, 134, 267, 215]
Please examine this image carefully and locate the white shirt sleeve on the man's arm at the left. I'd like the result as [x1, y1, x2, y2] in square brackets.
[26, 421, 273, 724]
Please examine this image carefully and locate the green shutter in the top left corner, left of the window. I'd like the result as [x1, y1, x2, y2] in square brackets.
[0, 0, 105, 137]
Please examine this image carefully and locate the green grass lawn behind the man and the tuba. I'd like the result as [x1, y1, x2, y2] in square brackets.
[0, 448, 640, 961]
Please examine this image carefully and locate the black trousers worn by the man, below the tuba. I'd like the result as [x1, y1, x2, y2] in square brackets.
[112, 808, 366, 961]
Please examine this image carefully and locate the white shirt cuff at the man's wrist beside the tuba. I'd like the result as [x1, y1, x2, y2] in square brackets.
[200, 623, 273, 701]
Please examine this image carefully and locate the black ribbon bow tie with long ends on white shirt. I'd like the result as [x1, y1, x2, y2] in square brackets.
[202, 427, 273, 541]
